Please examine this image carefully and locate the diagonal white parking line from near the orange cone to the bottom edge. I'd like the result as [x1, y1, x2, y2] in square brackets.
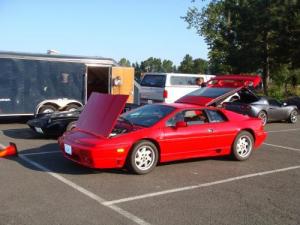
[19, 154, 149, 225]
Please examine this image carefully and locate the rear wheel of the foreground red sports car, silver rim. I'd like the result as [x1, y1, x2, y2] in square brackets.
[232, 131, 254, 161]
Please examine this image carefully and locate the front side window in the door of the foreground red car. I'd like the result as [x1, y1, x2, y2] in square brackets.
[166, 109, 208, 126]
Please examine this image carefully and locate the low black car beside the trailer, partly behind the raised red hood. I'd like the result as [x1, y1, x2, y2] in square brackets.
[27, 104, 138, 137]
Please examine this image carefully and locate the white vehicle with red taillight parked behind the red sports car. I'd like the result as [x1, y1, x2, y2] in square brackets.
[140, 73, 215, 104]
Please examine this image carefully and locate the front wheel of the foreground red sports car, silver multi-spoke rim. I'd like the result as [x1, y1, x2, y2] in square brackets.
[127, 141, 158, 175]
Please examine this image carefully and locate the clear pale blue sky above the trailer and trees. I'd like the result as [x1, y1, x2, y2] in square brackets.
[0, 0, 208, 65]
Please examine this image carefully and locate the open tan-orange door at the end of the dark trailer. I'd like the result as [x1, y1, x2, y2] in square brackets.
[111, 67, 134, 103]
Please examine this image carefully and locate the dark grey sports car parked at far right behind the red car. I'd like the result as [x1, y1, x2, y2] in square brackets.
[223, 88, 298, 125]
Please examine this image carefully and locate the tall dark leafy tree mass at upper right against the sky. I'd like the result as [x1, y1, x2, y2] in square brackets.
[183, 0, 300, 94]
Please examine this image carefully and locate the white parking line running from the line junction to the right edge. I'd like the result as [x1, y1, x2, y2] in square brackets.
[102, 165, 300, 206]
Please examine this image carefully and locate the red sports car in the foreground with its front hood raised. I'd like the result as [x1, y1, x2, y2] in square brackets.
[59, 93, 266, 174]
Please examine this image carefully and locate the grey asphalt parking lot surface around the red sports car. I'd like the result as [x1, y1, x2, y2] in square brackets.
[0, 118, 300, 225]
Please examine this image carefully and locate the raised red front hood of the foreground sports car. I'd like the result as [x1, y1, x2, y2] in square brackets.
[76, 92, 128, 137]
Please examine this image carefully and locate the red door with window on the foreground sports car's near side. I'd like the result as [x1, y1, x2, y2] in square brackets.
[160, 109, 214, 161]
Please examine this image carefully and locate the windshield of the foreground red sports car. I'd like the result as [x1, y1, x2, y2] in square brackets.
[122, 104, 175, 127]
